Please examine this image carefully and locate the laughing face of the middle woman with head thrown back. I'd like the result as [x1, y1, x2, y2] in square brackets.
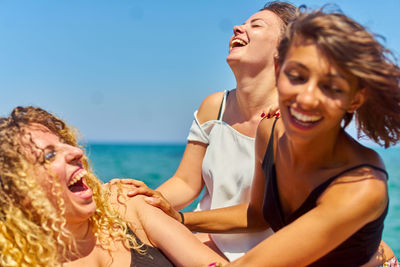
[226, 10, 282, 75]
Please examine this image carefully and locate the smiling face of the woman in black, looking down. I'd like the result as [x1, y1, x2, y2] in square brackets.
[277, 38, 363, 146]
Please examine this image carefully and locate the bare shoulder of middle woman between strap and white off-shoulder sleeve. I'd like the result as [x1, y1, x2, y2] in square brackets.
[197, 92, 224, 123]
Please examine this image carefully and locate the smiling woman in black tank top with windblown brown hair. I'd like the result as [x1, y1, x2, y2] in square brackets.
[180, 7, 400, 266]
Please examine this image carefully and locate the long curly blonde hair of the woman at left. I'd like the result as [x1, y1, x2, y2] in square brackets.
[0, 106, 141, 266]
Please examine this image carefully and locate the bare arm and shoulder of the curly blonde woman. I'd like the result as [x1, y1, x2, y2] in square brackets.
[114, 187, 226, 266]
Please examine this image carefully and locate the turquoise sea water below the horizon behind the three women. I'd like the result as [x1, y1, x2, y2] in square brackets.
[86, 144, 400, 257]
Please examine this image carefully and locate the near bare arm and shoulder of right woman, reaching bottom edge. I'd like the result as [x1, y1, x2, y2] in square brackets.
[229, 171, 387, 266]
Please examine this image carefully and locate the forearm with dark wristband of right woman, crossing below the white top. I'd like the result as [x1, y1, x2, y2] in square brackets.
[184, 203, 267, 233]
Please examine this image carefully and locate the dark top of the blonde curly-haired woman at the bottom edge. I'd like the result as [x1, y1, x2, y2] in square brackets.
[128, 229, 175, 267]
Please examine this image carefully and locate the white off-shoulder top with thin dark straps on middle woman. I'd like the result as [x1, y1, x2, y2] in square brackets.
[187, 91, 273, 261]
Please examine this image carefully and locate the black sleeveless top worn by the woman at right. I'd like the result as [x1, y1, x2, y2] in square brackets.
[262, 120, 388, 266]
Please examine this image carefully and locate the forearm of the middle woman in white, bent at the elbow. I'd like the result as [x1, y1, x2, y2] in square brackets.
[156, 176, 203, 213]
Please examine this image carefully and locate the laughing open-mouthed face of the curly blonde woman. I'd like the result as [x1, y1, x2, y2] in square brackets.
[22, 124, 96, 223]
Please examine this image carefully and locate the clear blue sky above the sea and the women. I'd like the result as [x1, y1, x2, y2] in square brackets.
[0, 0, 400, 147]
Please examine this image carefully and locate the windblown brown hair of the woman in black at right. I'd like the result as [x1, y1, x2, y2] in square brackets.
[278, 8, 400, 147]
